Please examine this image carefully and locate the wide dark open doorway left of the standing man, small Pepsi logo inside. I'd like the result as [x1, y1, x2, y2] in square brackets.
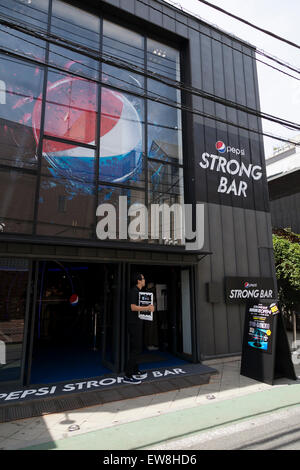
[30, 260, 120, 384]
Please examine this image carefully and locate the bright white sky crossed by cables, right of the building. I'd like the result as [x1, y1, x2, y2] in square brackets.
[165, 0, 300, 157]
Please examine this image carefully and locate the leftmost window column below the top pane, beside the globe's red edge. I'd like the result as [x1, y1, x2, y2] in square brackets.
[0, 57, 43, 234]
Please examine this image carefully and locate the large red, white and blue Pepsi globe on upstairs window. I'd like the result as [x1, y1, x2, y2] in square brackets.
[32, 77, 142, 193]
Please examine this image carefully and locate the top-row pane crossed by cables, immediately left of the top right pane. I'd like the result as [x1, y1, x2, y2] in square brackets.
[102, 21, 144, 92]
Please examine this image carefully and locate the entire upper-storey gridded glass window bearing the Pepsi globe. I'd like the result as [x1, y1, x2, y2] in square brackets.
[0, 0, 183, 243]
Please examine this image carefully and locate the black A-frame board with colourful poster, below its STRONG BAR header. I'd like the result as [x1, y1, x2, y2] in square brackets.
[241, 301, 297, 385]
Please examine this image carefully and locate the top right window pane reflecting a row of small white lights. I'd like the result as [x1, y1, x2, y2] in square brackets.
[147, 39, 180, 80]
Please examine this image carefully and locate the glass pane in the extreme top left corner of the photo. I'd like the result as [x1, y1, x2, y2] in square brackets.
[0, 0, 49, 29]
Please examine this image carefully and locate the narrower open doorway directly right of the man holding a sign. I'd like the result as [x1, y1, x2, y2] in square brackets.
[130, 265, 195, 369]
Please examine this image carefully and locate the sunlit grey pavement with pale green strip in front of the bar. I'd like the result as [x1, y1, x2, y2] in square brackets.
[0, 356, 300, 450]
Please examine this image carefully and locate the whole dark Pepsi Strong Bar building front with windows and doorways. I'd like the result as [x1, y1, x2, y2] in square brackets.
[0, 0, 275, 390]
